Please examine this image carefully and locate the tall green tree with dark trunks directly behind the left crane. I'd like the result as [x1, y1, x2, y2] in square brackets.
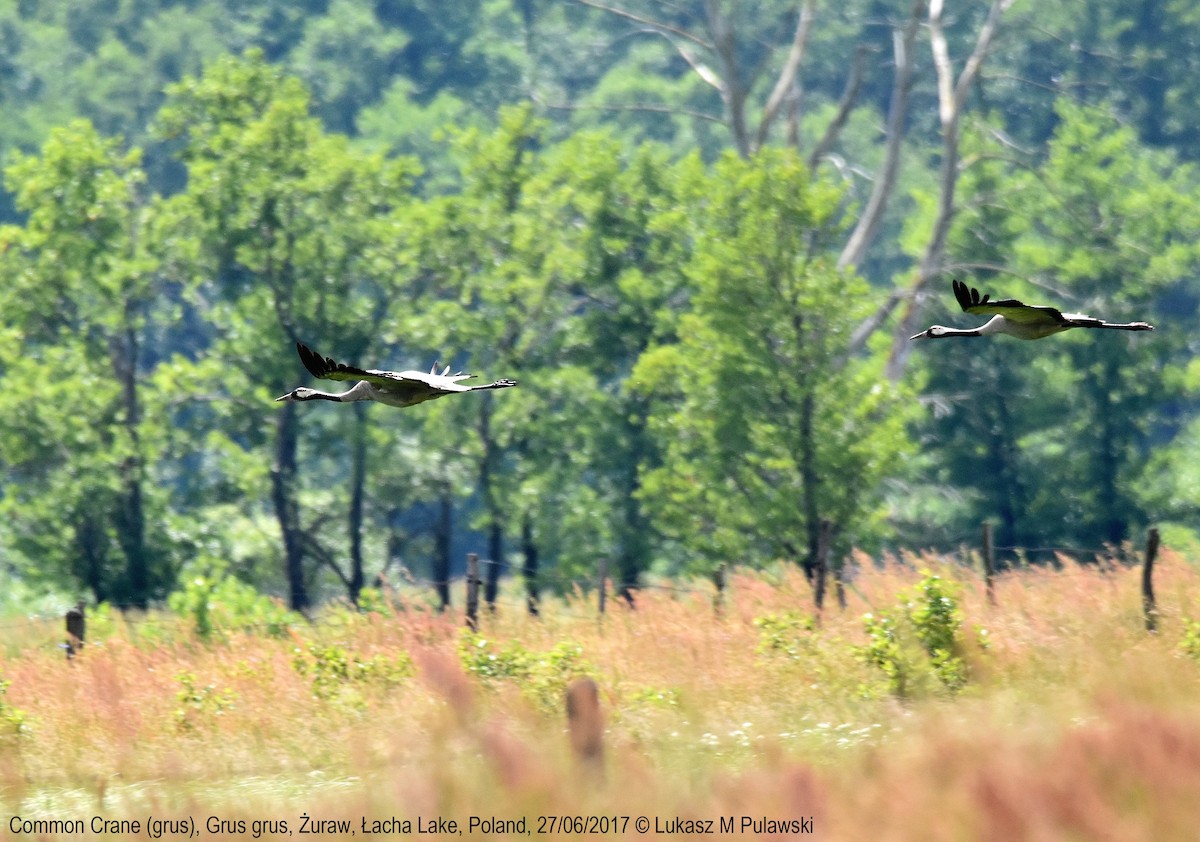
[160, 53, 412, 609]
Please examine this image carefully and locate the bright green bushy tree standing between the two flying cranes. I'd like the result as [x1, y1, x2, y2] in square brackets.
[634, 150, 905, 582]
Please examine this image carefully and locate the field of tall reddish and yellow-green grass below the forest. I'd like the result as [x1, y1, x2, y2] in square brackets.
[0, 551, 1200, 842]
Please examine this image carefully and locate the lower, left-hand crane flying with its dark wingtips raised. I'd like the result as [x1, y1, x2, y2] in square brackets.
[275, 342, 517, 407]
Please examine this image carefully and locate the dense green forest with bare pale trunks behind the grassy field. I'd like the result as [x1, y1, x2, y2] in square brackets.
[0, 0, 1200, 611]
